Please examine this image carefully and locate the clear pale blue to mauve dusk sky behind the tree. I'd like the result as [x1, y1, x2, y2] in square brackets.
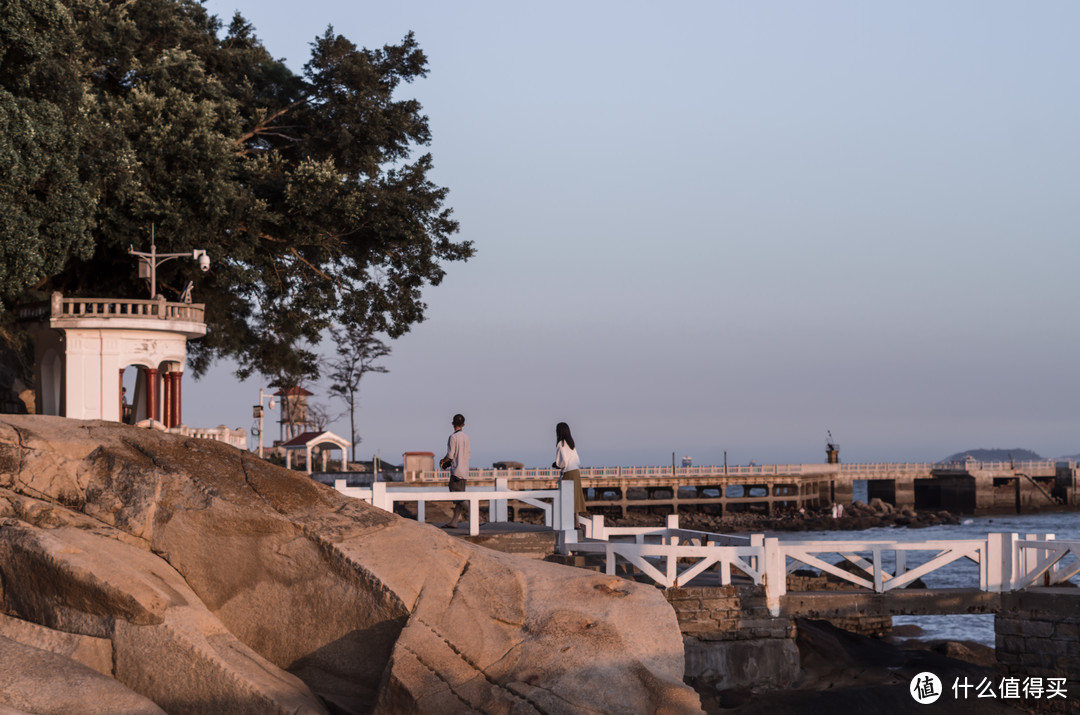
[184, 0, 1080, 468]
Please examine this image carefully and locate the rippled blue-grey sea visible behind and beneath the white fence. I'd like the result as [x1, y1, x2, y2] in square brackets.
[769, 512, 1080, 648]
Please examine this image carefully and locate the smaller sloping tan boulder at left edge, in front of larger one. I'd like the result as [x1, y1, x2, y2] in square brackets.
[0, 520, 325, 715]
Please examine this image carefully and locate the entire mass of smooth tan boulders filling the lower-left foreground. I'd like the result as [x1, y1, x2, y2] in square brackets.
[0, 416, 700, 713]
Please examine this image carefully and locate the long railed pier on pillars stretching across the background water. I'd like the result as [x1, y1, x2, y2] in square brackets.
[405, 459, 1080, 516]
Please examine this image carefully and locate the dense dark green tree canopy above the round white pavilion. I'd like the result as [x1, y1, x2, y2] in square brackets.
[0, 0, 473, 384]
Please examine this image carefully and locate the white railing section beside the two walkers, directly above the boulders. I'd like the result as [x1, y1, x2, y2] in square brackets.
[334, 478, 584, 543]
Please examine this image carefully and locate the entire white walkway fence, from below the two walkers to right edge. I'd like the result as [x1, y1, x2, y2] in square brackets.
[334, 478, 1080, 615]
